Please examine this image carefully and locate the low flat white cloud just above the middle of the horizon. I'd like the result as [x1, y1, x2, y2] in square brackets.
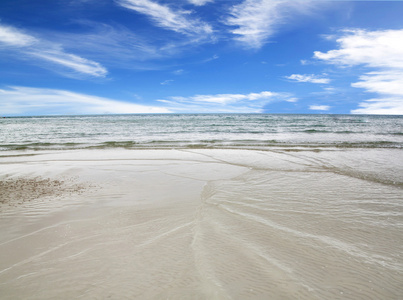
[157, 91, 296, 113]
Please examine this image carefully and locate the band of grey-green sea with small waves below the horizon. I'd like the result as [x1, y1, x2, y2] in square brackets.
[0, 114, 403, 151]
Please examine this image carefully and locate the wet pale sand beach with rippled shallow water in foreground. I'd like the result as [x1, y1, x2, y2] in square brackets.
[0, 148, 403, 299]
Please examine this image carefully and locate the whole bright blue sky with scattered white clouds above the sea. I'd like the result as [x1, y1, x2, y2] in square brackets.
[0, 0, 403, 116]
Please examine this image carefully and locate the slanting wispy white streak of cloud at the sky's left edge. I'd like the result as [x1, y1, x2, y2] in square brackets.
[0, 24, 108, 77]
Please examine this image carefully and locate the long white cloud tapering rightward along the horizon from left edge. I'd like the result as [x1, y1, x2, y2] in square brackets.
[0, 87, 170, 115]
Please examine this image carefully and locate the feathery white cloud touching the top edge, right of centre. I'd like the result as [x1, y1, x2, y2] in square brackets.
[225, 0, 319, 48]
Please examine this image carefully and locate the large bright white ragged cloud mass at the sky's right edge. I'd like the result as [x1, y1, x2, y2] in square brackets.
[314, 29, 403, 114]
